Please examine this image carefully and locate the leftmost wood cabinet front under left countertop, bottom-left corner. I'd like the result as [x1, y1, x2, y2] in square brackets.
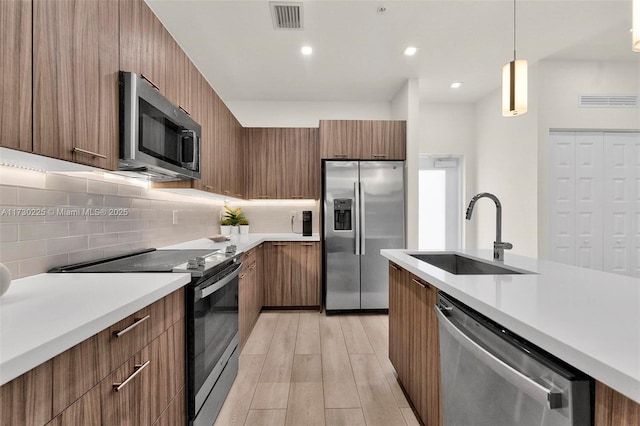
[0, 361, 53, 426]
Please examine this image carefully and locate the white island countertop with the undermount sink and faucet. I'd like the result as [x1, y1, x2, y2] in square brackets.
[381, 250, 640, 403]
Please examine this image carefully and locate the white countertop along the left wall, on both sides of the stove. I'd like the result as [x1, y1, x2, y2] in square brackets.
[0, 234, 320, 385]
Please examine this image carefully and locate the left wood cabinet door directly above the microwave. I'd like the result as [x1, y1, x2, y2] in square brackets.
[119, 0, 166, 95]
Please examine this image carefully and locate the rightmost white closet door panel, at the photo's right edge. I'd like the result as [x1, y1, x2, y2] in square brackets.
[604, 132, 640, 277]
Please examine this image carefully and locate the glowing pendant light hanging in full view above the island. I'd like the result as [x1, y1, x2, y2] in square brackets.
[502, 0, 527, 117]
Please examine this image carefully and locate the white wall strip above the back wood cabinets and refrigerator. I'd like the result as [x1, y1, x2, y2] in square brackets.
[226, 101, 391, 127]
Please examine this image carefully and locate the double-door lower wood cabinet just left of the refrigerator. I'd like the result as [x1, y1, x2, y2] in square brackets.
[263, 241, 320, 307]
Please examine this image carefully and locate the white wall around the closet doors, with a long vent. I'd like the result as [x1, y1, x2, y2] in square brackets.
[538, 57, 640, 258]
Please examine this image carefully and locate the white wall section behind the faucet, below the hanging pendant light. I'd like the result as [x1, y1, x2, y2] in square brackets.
[472, 67, 538, 257]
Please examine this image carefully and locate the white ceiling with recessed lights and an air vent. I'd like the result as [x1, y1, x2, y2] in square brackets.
[146, 0, 640, 102]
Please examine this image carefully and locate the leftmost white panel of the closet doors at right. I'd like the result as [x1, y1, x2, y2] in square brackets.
[549, 132, 576, 265]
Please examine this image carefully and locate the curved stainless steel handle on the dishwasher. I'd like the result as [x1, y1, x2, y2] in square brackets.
[433, 305, 562, 410]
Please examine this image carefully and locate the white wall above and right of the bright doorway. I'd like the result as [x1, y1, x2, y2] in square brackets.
[419, 103, 476, 247]
